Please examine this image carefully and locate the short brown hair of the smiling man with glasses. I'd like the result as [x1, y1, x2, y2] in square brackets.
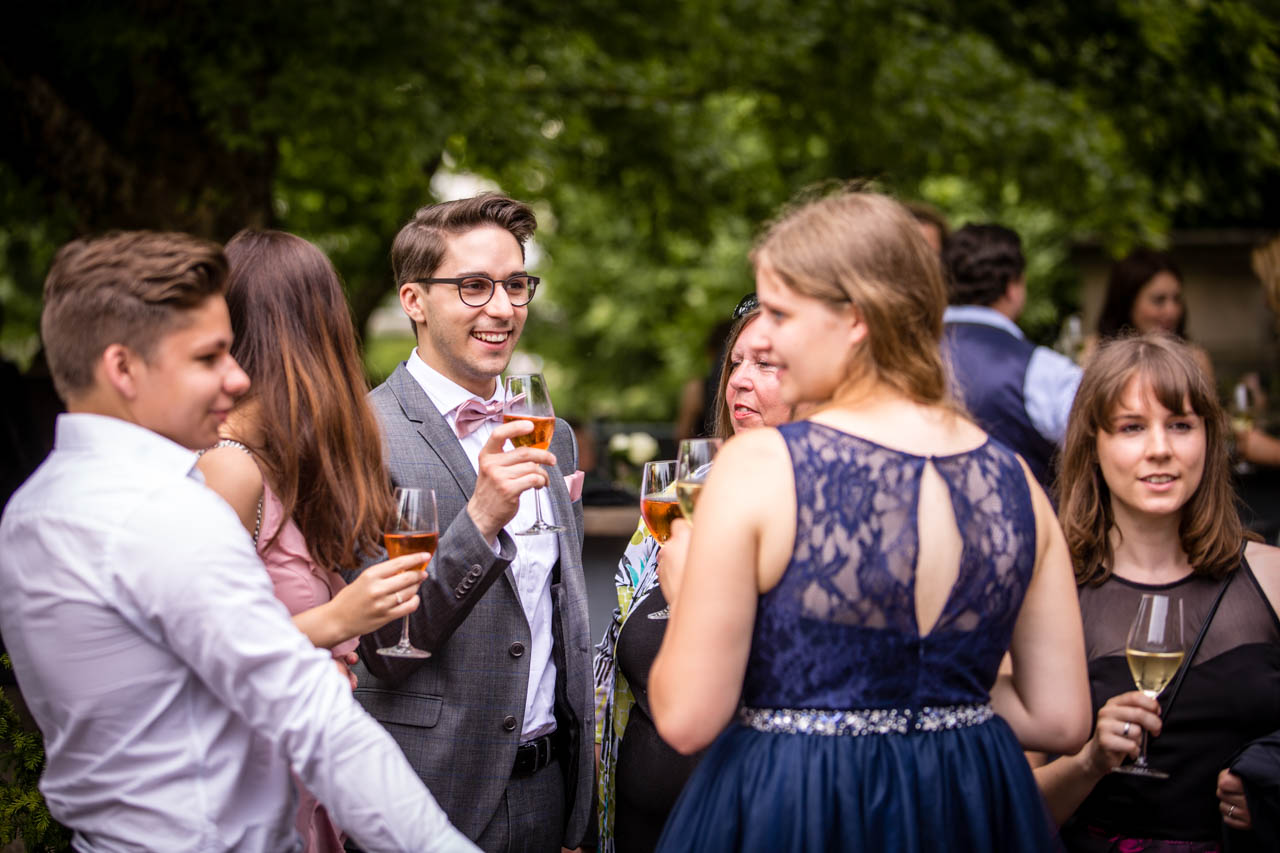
[392, 192, 538, 288]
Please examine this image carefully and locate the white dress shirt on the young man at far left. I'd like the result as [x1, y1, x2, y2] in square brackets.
[0, 414, 475, 850]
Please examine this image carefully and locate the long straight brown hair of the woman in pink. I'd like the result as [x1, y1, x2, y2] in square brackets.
[227, 231, 392, 569]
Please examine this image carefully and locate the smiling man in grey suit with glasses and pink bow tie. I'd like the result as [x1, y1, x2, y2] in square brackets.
[356, 193, 595, 852]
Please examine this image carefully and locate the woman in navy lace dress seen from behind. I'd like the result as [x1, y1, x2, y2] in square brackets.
[649, 192, 1089, 850]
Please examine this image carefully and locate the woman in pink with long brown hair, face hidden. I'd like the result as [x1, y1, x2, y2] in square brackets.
[200, 231, 424, 852]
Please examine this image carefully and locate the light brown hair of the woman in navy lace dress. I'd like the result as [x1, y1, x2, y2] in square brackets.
[751, 188, 947, 403]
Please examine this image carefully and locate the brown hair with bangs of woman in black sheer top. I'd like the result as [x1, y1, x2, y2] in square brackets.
[1057, 333, 1245, 585]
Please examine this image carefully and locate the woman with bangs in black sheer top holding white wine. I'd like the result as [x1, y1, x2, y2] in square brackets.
[1036, 336, 1280, 853]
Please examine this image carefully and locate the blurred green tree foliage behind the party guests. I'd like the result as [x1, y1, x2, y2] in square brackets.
[0, 0, 1280, 420]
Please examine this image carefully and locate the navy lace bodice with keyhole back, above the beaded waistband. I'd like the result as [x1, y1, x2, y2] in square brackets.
[742, 421, 1036, 708]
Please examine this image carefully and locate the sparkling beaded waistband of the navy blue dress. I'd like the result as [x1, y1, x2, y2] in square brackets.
[737, 703, 996, 736]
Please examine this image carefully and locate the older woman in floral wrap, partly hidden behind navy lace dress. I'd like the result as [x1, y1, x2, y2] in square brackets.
[595, 293, 792, 853]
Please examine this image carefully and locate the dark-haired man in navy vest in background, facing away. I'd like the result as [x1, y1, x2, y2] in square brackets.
[942, 224, 1082, 494]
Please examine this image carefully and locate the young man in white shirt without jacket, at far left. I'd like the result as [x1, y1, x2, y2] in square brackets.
[0, 232, 475, 850]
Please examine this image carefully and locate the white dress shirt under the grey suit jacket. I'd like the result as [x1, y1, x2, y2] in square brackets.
[404, 348, 559, 742]
